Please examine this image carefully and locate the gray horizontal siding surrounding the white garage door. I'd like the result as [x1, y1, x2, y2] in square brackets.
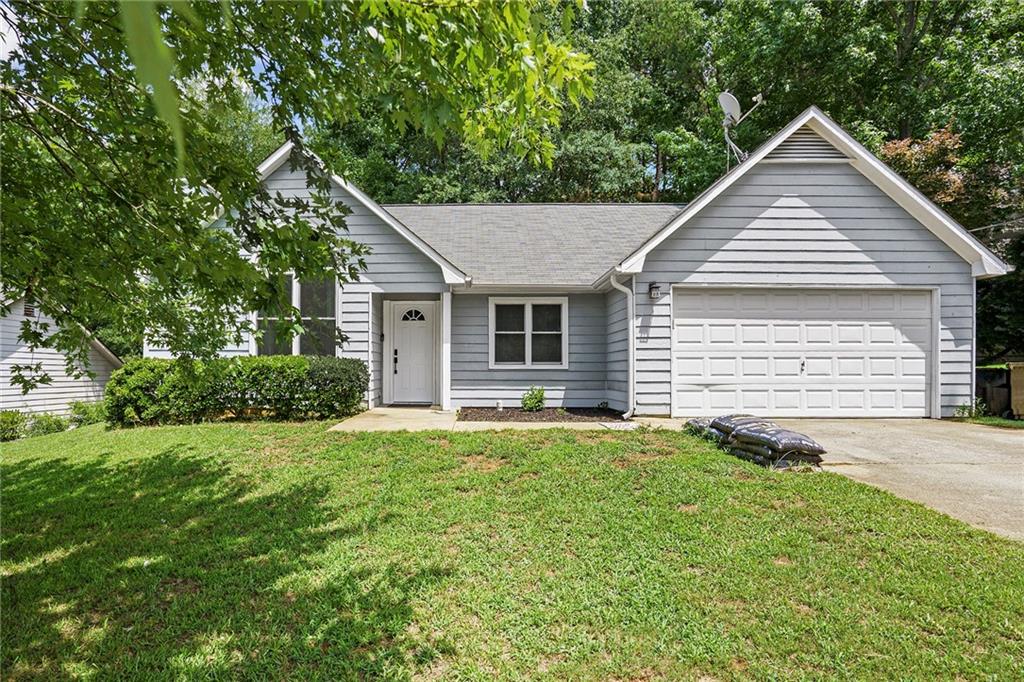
[636, 162, 975, 416]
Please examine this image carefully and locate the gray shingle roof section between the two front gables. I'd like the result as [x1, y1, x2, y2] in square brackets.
[384, 204, 684, 286]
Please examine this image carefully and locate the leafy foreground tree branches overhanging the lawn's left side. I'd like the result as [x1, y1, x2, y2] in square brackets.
[0, 0, 591, 389]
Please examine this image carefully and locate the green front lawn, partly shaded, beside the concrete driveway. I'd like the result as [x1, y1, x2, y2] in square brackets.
[6, 423, 1024, 680]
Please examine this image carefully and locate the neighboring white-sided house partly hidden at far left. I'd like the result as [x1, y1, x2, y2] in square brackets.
[0, 298, 121, 415]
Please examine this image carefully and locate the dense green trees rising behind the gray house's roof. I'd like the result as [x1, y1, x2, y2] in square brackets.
[314, 0, 1024, 364]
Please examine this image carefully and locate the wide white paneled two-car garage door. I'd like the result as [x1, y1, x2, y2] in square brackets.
[673, 288, 932, 417]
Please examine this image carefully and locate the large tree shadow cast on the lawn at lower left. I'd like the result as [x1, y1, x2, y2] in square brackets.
[0, 447, 446, 679]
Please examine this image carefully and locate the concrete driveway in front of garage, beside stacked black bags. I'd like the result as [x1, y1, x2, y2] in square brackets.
[776, 419, 1024, 541]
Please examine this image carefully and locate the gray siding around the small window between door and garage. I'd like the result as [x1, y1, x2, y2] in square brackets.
[452, 294, 607, 408]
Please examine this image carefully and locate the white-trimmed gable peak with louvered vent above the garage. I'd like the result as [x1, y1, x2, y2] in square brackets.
[612, 106, 1010, 278]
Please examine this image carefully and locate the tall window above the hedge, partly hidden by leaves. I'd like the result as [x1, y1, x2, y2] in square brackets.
[256, 275, 337, 355]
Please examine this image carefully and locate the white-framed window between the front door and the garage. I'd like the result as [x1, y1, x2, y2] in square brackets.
[489, 298, 568, 369]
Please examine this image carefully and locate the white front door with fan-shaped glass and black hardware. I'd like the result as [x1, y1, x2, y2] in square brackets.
[390, 301, 437, 404]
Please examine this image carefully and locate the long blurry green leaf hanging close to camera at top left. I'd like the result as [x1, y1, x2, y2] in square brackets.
[120, 0, 185, 170]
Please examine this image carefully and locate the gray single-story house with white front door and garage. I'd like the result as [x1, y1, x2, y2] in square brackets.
[145, 108, 1008, 417]
